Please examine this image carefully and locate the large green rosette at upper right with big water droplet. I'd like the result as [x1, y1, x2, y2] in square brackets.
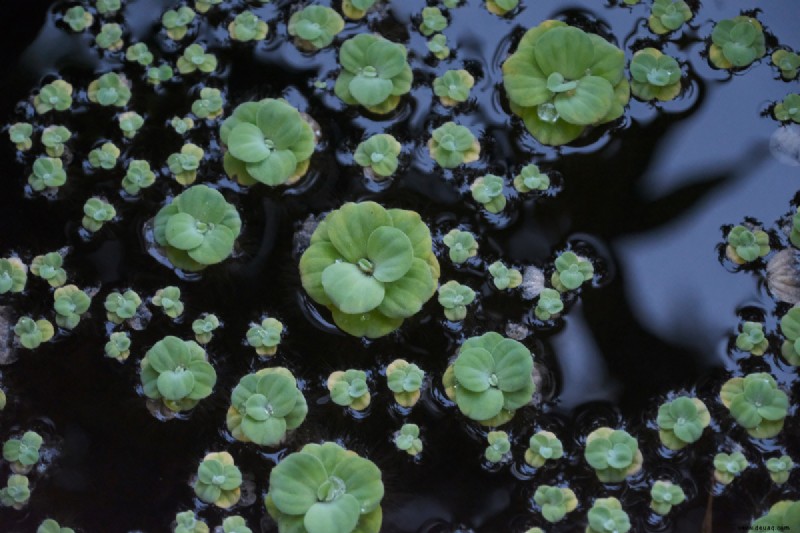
[503, 20, 630, 146]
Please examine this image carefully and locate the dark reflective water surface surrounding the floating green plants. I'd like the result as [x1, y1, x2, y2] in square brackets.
[0, 0, 800, 533]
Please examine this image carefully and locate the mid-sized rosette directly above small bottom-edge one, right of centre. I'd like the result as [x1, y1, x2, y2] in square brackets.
[583, 427, 643, 483]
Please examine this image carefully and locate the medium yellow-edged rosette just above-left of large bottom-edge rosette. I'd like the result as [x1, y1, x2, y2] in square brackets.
[226, 367, 308, 446]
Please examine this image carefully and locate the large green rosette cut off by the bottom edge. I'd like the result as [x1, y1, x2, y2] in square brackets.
[264, 442, 383, 533]
